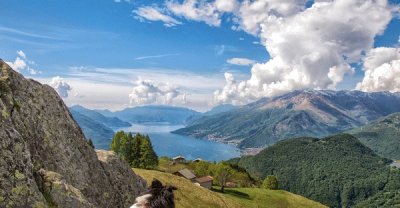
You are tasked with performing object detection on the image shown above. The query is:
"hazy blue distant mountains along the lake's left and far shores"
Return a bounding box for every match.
[69,105,202,150]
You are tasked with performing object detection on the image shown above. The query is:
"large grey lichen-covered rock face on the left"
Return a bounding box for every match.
[0,60,145,207]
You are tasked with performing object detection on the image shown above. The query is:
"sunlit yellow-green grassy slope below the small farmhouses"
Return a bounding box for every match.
[134,169,324,208]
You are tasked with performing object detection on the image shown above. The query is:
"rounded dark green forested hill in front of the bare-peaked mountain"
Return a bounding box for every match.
[232,134,400,207]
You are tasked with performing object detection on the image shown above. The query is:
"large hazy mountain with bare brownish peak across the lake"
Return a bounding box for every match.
[173,90,400,148]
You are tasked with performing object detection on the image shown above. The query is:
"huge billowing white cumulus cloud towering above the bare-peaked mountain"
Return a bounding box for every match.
[214,0,392,103]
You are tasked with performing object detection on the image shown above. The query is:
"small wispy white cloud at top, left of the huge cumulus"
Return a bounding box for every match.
[133,6,182,27]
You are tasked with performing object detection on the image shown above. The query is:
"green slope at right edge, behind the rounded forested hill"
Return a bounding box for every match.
[349,113,400,160]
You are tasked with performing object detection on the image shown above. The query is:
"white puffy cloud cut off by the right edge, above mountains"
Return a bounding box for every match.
[356,47,400,92]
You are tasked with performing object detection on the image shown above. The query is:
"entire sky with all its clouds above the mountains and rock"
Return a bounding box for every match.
[0,0,400,111]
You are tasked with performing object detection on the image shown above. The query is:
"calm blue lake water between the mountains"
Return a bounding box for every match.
[115,123,240,161]
